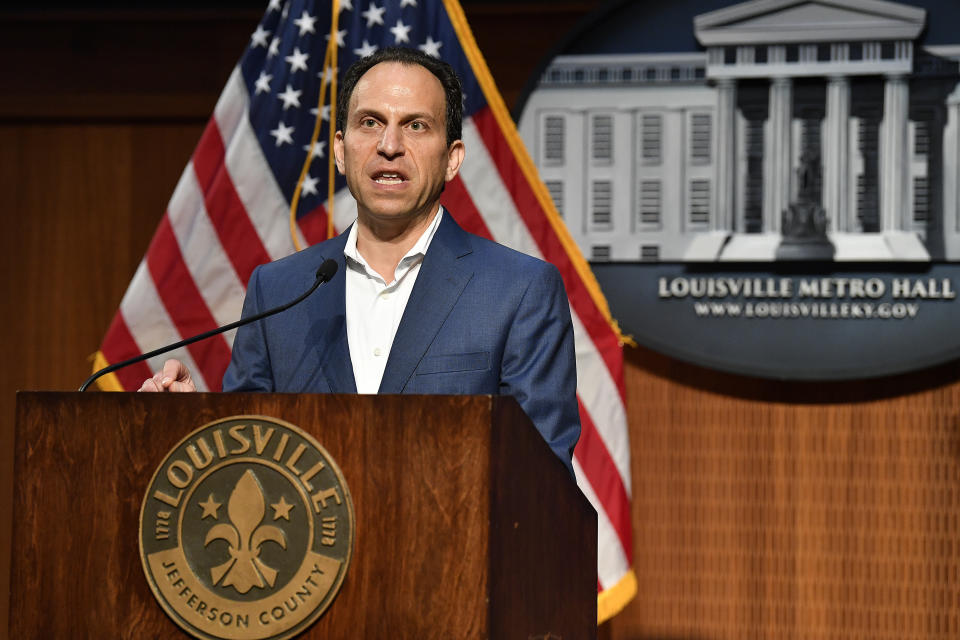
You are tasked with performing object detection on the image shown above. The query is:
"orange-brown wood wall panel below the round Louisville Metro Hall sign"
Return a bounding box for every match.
[611,350,960,640]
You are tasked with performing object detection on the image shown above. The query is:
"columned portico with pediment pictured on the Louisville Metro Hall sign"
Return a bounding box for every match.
[694,0,928,260]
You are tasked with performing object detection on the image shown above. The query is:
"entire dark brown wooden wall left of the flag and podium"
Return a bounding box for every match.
[0,12,249,638]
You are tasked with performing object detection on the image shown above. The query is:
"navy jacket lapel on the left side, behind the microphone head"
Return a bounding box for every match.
[305,232,357,393]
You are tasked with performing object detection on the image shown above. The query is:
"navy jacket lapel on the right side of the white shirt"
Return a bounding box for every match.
[379,212,473,393]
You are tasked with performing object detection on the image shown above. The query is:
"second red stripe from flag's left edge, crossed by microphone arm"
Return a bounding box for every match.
[147,215,230,391]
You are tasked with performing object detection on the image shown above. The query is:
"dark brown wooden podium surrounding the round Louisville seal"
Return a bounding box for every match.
[10,392,597,640]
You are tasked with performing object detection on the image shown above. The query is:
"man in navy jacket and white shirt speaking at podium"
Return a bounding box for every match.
[140,48,580,473]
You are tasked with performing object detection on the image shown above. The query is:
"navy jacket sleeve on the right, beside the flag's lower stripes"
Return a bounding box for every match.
[500,263,580,475]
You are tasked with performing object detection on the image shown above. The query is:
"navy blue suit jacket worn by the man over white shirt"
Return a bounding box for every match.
[223,212,580,472]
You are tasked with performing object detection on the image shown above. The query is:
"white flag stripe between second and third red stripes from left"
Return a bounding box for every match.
[167,161,244,336]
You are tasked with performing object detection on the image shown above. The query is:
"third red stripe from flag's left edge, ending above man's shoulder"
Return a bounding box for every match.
[193,118,270,286]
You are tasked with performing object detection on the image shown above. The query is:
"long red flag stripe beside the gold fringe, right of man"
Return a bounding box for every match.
[473,107,626,404]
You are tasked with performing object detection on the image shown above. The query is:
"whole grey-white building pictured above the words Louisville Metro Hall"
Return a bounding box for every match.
[520,0,960,262]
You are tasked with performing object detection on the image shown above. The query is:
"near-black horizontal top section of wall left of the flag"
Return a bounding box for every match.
[0,11,255,123]
